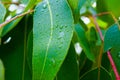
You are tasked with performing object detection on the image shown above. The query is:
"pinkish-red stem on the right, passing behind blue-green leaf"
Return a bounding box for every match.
[93,16,120,80]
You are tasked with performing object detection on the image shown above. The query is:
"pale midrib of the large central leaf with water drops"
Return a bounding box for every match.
[40,0,53,80]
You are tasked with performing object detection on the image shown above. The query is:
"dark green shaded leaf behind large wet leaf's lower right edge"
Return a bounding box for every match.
[56,44,79,80]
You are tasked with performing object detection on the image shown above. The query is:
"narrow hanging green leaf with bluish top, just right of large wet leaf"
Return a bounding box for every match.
[75,24,95,61]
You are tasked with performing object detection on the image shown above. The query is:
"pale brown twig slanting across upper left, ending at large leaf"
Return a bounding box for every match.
[0,10,34,29]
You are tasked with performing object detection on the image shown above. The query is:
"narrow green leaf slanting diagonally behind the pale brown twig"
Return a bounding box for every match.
[1,0,36,37]
